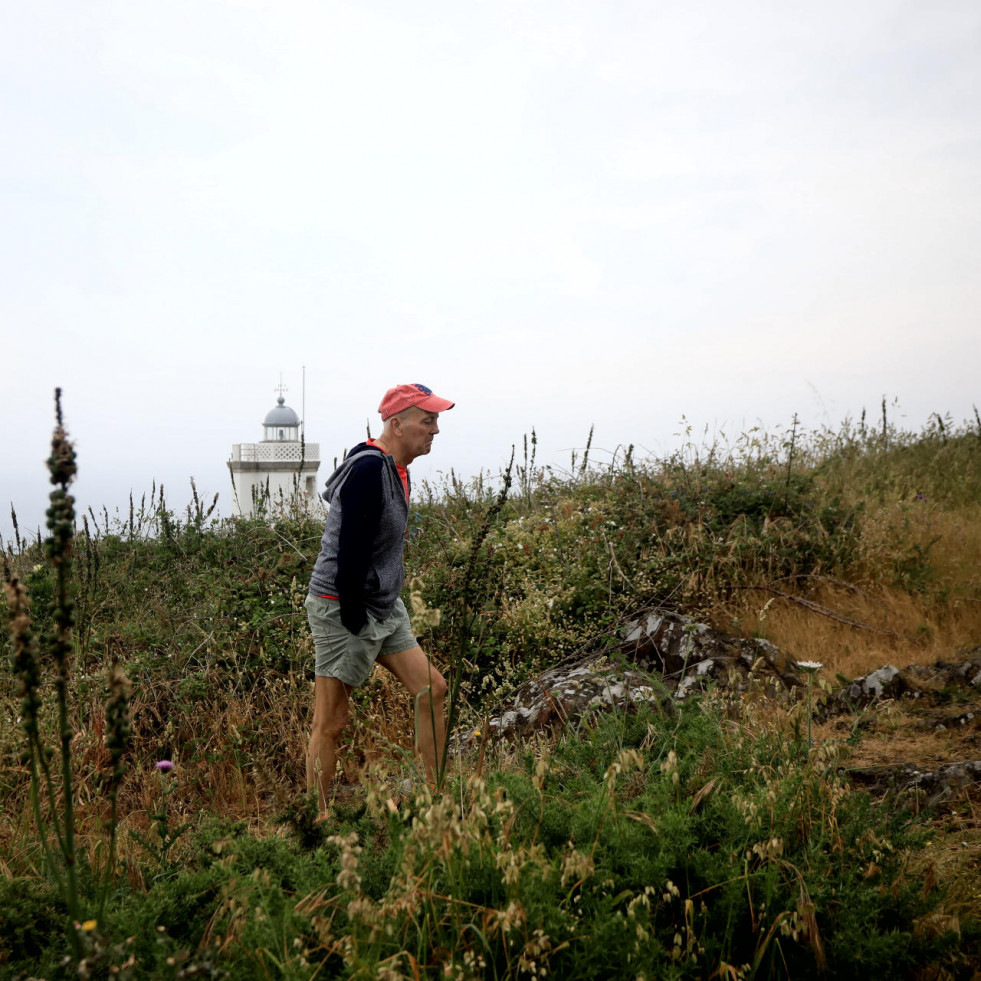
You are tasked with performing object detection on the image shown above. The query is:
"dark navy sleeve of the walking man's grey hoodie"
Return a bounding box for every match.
[337,453,384,634]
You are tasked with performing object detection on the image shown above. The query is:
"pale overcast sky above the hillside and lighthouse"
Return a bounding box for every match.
[0,0,981,540]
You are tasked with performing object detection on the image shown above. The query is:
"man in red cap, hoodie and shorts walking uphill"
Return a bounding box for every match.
[306,385,454,819]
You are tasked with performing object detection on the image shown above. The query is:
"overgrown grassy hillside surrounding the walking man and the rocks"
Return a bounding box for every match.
[0,394,981,978]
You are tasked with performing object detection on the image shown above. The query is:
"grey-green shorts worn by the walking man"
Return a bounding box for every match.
[304,594,416,688]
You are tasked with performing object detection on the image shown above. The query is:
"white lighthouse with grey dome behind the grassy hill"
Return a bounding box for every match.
[228,385,320,517]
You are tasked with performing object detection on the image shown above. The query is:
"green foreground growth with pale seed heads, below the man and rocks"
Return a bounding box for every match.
[0,705,954,978]
